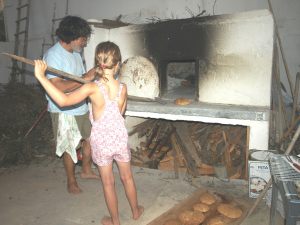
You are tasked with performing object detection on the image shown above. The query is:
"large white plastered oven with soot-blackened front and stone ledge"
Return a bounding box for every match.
[85,10,274,153]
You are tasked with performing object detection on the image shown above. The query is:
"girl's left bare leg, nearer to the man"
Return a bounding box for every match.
[98,163,120,225]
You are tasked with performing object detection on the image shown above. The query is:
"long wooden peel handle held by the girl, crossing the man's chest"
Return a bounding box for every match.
[0,52,89,84]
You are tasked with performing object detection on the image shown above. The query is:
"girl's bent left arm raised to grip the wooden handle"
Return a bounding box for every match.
[34,60,93,107]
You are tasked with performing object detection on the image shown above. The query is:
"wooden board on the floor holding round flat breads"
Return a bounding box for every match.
[147,188,251,225]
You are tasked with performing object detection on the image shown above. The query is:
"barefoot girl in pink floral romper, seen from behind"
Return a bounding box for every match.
[35,41,144,225]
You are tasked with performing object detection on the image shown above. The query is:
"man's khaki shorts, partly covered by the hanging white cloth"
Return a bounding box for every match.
[50,112,92,142]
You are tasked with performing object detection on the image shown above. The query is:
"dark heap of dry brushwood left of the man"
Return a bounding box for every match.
[0,83,53,167]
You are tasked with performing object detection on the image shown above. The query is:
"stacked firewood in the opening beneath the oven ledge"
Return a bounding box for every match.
[129,119,248,179]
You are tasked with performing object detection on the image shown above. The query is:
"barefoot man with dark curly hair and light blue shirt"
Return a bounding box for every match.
[44,16,99,194]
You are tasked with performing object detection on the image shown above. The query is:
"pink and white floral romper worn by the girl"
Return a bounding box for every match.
[90,81,131,166]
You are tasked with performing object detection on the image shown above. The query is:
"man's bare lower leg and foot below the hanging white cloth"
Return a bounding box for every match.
[63,152,81,194]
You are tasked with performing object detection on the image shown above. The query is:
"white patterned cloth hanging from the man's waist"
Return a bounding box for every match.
[56,113,81,163]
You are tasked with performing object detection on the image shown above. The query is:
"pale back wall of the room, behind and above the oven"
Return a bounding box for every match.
[0,0,300,99]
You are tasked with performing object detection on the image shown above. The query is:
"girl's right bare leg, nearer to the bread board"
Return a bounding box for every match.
[117,162,144,220]
